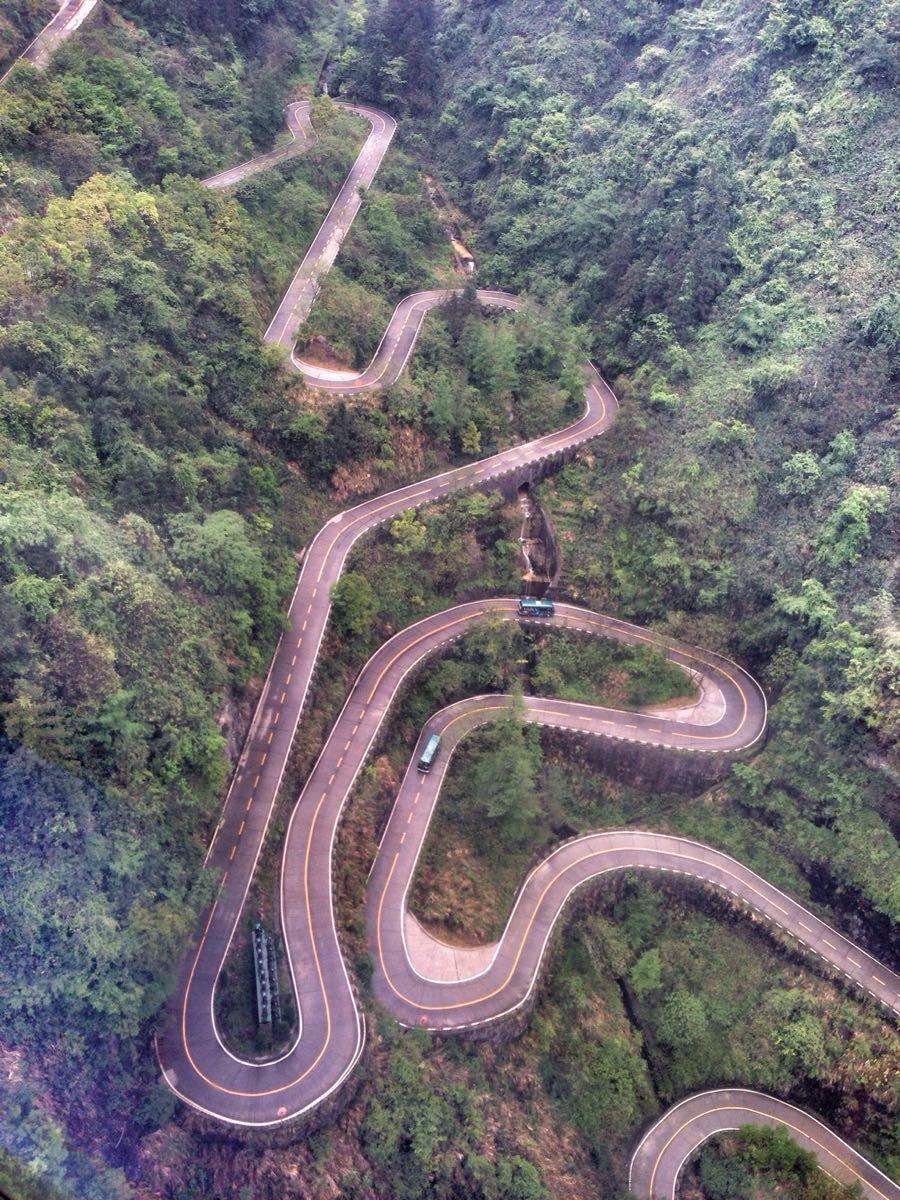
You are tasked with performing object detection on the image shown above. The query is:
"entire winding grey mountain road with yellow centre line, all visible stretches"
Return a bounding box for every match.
[8,35,900,1200]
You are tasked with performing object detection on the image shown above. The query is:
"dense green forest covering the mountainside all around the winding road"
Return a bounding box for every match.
[0,0,900,1200]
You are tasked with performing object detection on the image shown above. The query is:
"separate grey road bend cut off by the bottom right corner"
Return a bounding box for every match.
[629,1087,900,1200]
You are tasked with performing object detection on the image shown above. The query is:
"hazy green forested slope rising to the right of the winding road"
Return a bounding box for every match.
[369,0,900,922]
